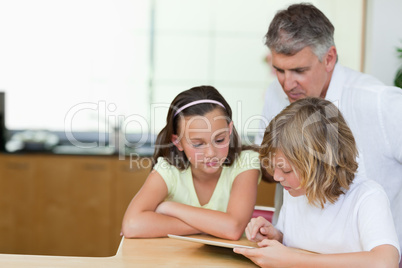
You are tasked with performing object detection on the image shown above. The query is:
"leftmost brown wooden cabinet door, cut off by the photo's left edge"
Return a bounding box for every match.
[0,155,35,254]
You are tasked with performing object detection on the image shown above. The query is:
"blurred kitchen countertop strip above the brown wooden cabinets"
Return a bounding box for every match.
[4,130,155,157]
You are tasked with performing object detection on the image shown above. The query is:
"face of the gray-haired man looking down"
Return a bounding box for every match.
[271,47,336,102]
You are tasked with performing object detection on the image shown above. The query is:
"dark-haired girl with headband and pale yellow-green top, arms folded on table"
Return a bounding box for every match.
[122,86,261,240]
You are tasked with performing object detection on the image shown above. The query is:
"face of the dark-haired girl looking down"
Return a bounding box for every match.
[172,108,233,174]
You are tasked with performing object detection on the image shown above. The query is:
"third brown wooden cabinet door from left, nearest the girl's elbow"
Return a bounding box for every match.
[72,157,116,256]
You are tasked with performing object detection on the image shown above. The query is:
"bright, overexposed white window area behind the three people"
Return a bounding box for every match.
[0,0,374,149]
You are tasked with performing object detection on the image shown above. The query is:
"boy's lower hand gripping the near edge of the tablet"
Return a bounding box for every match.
[233,239,295,267]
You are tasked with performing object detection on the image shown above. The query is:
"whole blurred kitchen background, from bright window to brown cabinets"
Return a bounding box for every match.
[0,0,402,256]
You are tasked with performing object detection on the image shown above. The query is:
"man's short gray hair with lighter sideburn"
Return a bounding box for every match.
[265,3,335,61]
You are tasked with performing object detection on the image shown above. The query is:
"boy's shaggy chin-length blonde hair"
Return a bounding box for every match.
[260,98,358,208]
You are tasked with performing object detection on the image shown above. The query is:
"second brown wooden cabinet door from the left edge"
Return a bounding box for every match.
[32,156,76,255]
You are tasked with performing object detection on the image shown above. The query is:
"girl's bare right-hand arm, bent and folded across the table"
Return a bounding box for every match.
[158,169,260,240]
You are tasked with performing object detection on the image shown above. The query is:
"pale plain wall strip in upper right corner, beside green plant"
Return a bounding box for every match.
[364,0,402,85]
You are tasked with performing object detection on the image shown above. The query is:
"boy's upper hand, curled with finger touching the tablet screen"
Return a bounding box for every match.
[245,216,282,242]
